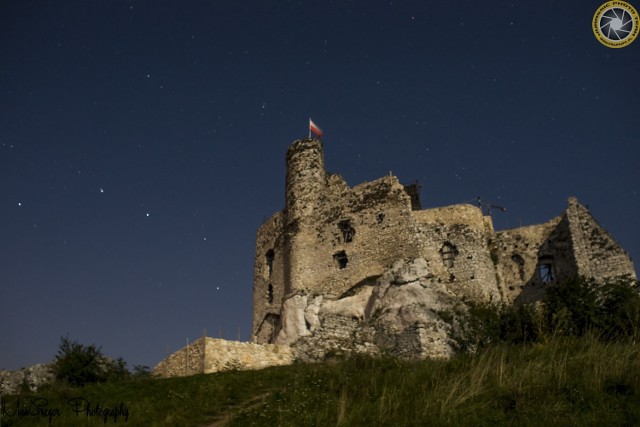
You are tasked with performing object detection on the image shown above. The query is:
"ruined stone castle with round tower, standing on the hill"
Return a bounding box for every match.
[253,139,635,356]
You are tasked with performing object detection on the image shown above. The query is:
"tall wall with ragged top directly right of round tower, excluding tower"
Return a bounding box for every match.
[292,175,418,298]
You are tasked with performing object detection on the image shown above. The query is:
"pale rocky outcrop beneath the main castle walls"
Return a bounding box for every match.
[276,258,466,361]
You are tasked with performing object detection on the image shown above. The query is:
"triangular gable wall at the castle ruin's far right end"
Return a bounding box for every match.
[566,197,636,279]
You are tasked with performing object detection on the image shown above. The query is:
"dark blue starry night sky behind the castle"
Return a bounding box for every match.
[0,0,640,369]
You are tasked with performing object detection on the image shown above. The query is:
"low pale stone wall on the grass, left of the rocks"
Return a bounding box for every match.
[153,337,294,378]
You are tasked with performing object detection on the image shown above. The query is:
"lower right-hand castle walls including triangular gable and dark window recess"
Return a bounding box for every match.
[490,198,635,302]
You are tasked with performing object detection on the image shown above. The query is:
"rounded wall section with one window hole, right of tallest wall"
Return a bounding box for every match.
[412,204,502,302]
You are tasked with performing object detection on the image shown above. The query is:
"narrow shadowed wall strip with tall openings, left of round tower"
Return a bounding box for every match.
[252,212,285,342]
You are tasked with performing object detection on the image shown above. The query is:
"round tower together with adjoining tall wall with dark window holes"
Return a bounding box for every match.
[284,140,418,297]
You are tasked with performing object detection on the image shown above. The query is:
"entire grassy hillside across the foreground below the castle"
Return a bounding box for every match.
[2,337,640,427]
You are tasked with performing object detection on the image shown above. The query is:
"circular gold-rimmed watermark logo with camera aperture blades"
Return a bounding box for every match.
[592,1,640,48]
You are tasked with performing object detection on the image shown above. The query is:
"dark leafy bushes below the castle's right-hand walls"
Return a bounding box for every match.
[454,277,640,352]
